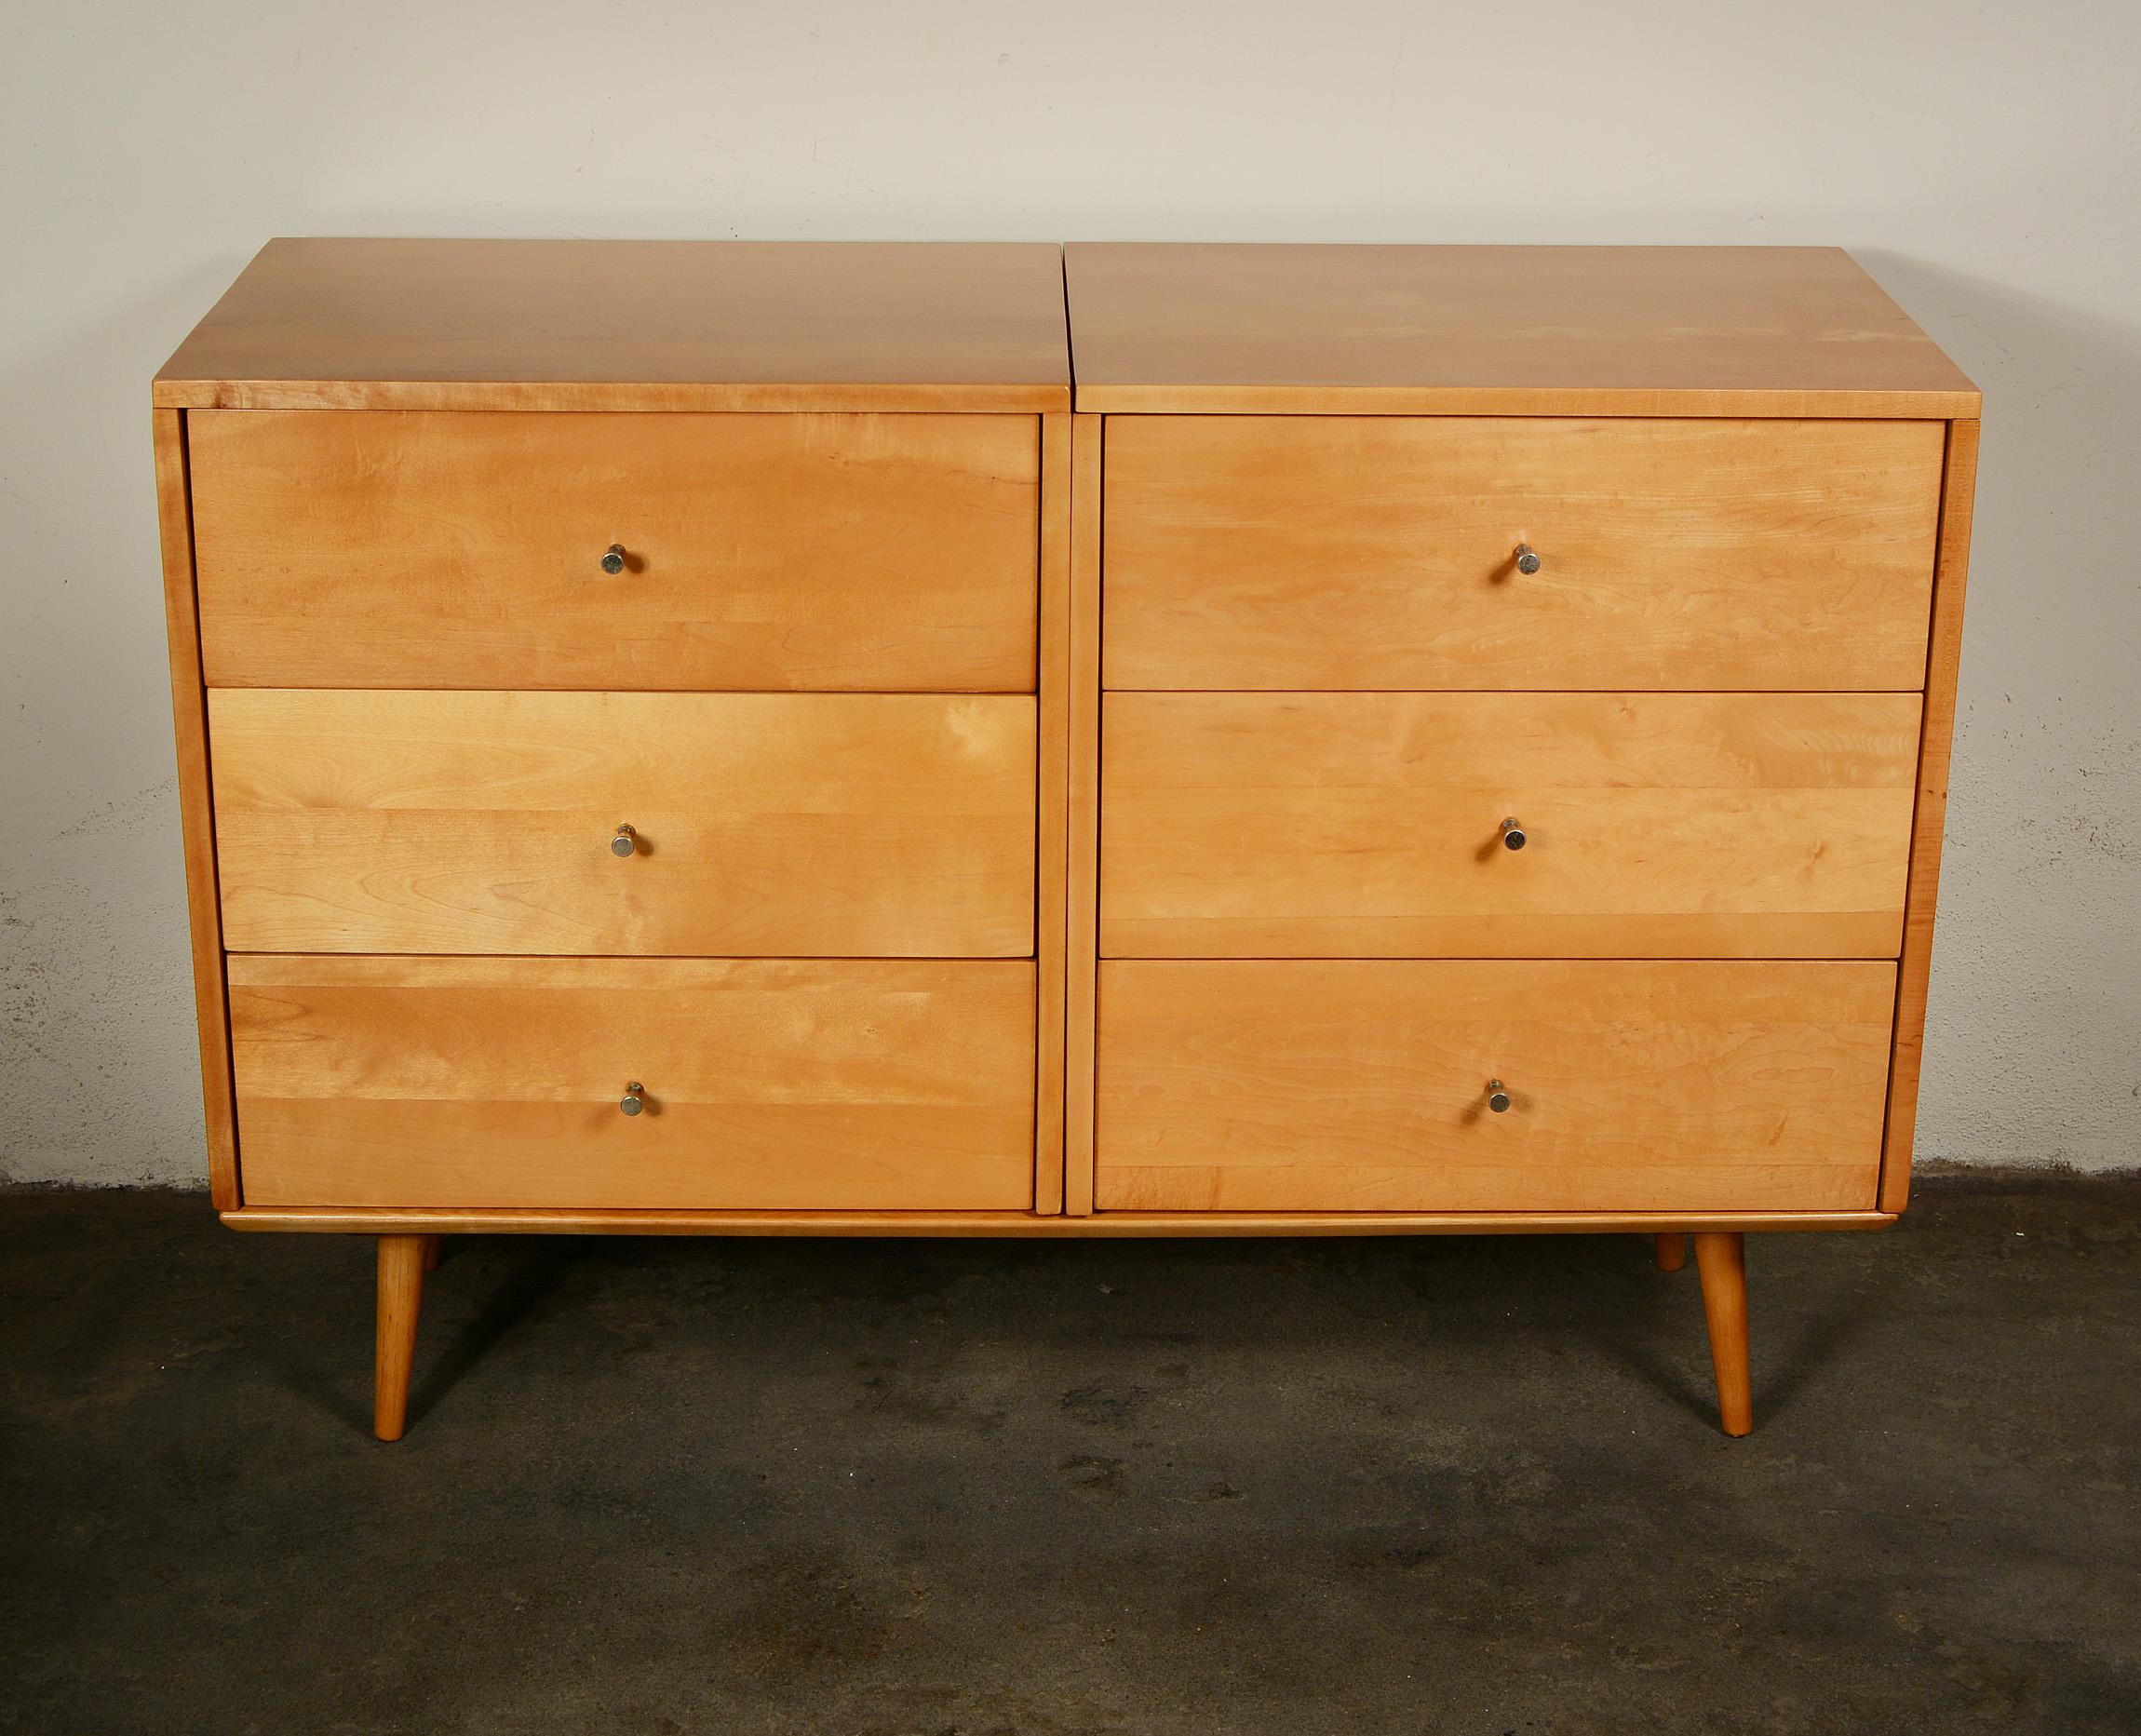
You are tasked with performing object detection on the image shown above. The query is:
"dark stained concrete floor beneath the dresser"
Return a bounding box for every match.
[0,1178,2141,1736]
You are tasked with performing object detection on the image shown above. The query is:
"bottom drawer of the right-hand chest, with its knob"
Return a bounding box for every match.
[1094,959,1895,1212]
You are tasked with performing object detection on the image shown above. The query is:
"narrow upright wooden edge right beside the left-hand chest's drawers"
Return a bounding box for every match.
[1034,415,1070,1214]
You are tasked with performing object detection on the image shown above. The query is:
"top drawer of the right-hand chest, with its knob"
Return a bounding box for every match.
[1103,415,1944,692]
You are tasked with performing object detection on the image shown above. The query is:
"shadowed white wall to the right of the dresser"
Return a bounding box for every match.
[1858,252,2141,1169]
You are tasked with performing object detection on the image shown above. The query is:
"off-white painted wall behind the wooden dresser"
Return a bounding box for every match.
[0,0,2141,1181]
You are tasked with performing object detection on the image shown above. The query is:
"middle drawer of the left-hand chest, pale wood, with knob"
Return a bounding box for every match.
[208,687,1036,957]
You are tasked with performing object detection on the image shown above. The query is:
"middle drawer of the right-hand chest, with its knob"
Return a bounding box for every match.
[1100,693,1920,959]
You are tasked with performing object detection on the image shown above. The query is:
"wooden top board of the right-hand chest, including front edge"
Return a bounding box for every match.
[1064,242,1978,417]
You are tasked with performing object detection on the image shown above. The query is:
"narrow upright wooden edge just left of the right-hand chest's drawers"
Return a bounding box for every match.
[1064,415,1105,1216]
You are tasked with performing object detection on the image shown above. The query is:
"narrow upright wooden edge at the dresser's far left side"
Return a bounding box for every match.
[155,409,242,1212]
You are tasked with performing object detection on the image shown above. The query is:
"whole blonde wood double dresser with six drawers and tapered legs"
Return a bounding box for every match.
[155,242,1978,1438]
